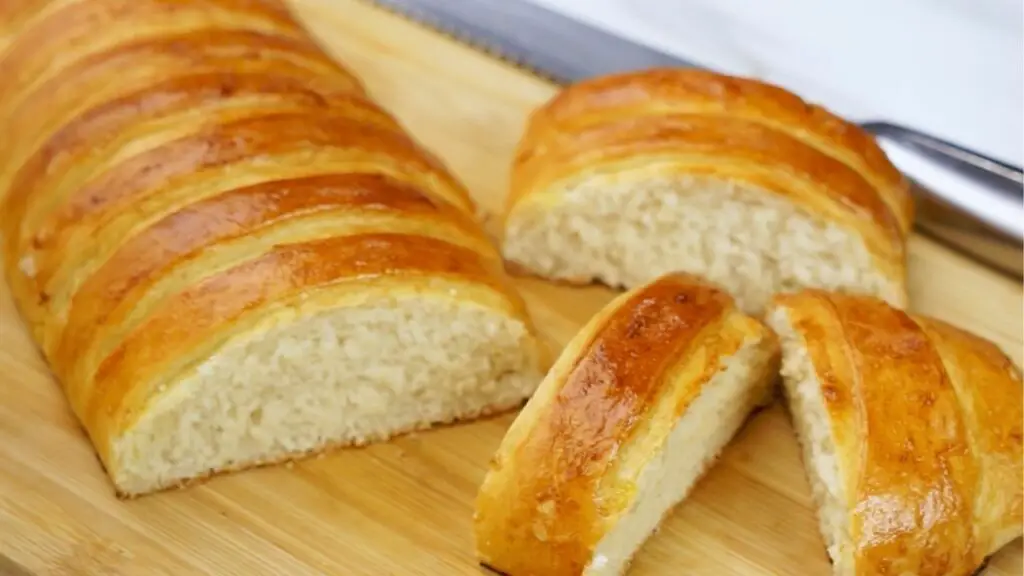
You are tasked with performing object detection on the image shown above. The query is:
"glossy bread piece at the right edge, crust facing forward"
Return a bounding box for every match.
[768,290,1024,576]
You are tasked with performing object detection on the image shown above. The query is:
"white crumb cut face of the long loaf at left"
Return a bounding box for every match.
[108,297,543,497]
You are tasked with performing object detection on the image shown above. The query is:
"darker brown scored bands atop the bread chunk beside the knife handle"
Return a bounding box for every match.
[512,69,913,235]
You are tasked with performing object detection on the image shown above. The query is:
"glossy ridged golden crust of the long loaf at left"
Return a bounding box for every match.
[0,0,532,479]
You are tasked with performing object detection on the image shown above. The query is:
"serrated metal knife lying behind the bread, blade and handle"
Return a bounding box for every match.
[371,0,1024,278]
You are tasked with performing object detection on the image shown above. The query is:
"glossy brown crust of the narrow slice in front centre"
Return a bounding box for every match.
[475,274,773,576]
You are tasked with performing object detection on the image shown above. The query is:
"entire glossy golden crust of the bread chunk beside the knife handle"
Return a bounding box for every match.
[505,69,913,281]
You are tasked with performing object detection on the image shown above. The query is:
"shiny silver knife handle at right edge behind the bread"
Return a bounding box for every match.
[862,122,1024,278]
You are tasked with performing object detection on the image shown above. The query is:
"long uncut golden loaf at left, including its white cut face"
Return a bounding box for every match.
[0,0,543,495]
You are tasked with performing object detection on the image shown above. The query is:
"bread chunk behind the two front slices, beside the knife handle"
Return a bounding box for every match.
[503,69,912,314]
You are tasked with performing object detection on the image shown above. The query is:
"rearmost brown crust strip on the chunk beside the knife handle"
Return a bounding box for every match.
[513,69,913,235]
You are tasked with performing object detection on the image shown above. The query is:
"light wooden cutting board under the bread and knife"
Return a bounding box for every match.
[0,0,1024,576]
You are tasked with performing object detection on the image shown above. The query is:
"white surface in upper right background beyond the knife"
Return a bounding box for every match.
[524,0,1024,165]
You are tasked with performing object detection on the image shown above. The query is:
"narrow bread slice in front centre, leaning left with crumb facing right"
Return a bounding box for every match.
[474,275,778,576]
